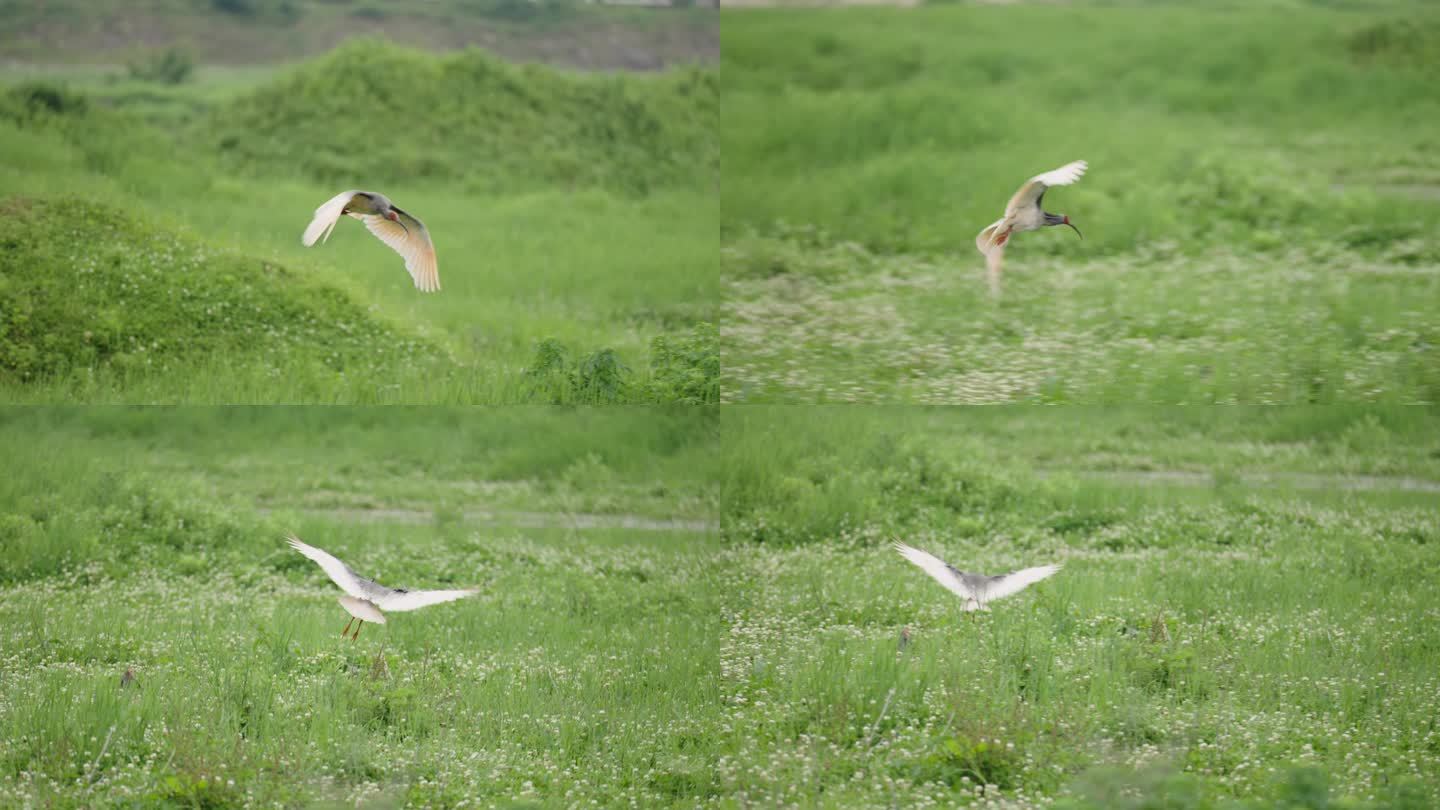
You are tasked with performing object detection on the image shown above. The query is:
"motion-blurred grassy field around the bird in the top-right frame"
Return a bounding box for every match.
[721,3,1440,404]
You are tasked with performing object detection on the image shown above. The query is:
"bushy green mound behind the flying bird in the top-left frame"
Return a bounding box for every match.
[207,40,720,193]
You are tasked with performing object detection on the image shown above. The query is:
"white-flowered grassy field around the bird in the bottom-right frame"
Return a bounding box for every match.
[717,406,1440,810]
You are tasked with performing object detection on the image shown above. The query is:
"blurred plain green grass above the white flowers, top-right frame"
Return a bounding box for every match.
[721,4,1440,257]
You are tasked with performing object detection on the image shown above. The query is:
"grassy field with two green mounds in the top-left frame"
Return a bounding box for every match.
[0,40,719,404]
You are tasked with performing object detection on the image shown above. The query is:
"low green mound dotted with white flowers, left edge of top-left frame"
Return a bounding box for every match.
[0,197,444,382]
